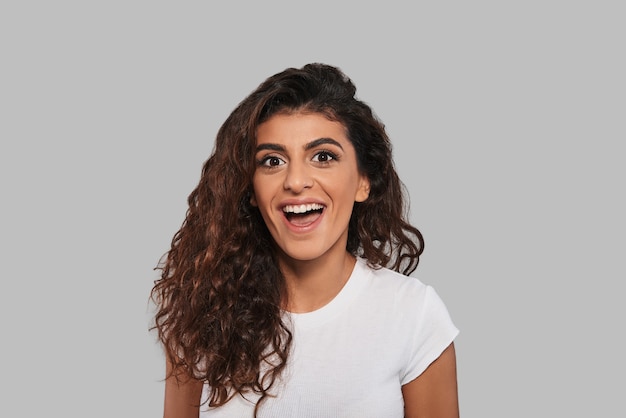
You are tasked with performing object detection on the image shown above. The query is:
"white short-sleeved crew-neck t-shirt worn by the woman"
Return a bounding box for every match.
[200,259,459,418]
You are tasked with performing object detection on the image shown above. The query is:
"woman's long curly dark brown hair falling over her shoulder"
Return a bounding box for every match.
[151,63,424,410]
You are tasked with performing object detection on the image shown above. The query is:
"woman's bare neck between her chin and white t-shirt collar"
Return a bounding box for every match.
[280,252,356,313]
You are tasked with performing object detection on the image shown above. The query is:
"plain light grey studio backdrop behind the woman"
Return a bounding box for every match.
[0,0,626,418]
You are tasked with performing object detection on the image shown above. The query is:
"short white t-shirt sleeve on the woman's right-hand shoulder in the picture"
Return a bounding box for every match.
[400,286,459,385]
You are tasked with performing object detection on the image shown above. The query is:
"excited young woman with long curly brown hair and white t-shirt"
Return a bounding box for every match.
[152,64,459,418]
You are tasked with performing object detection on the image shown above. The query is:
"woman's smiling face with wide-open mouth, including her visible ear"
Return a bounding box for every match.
[250,113,369,261]
